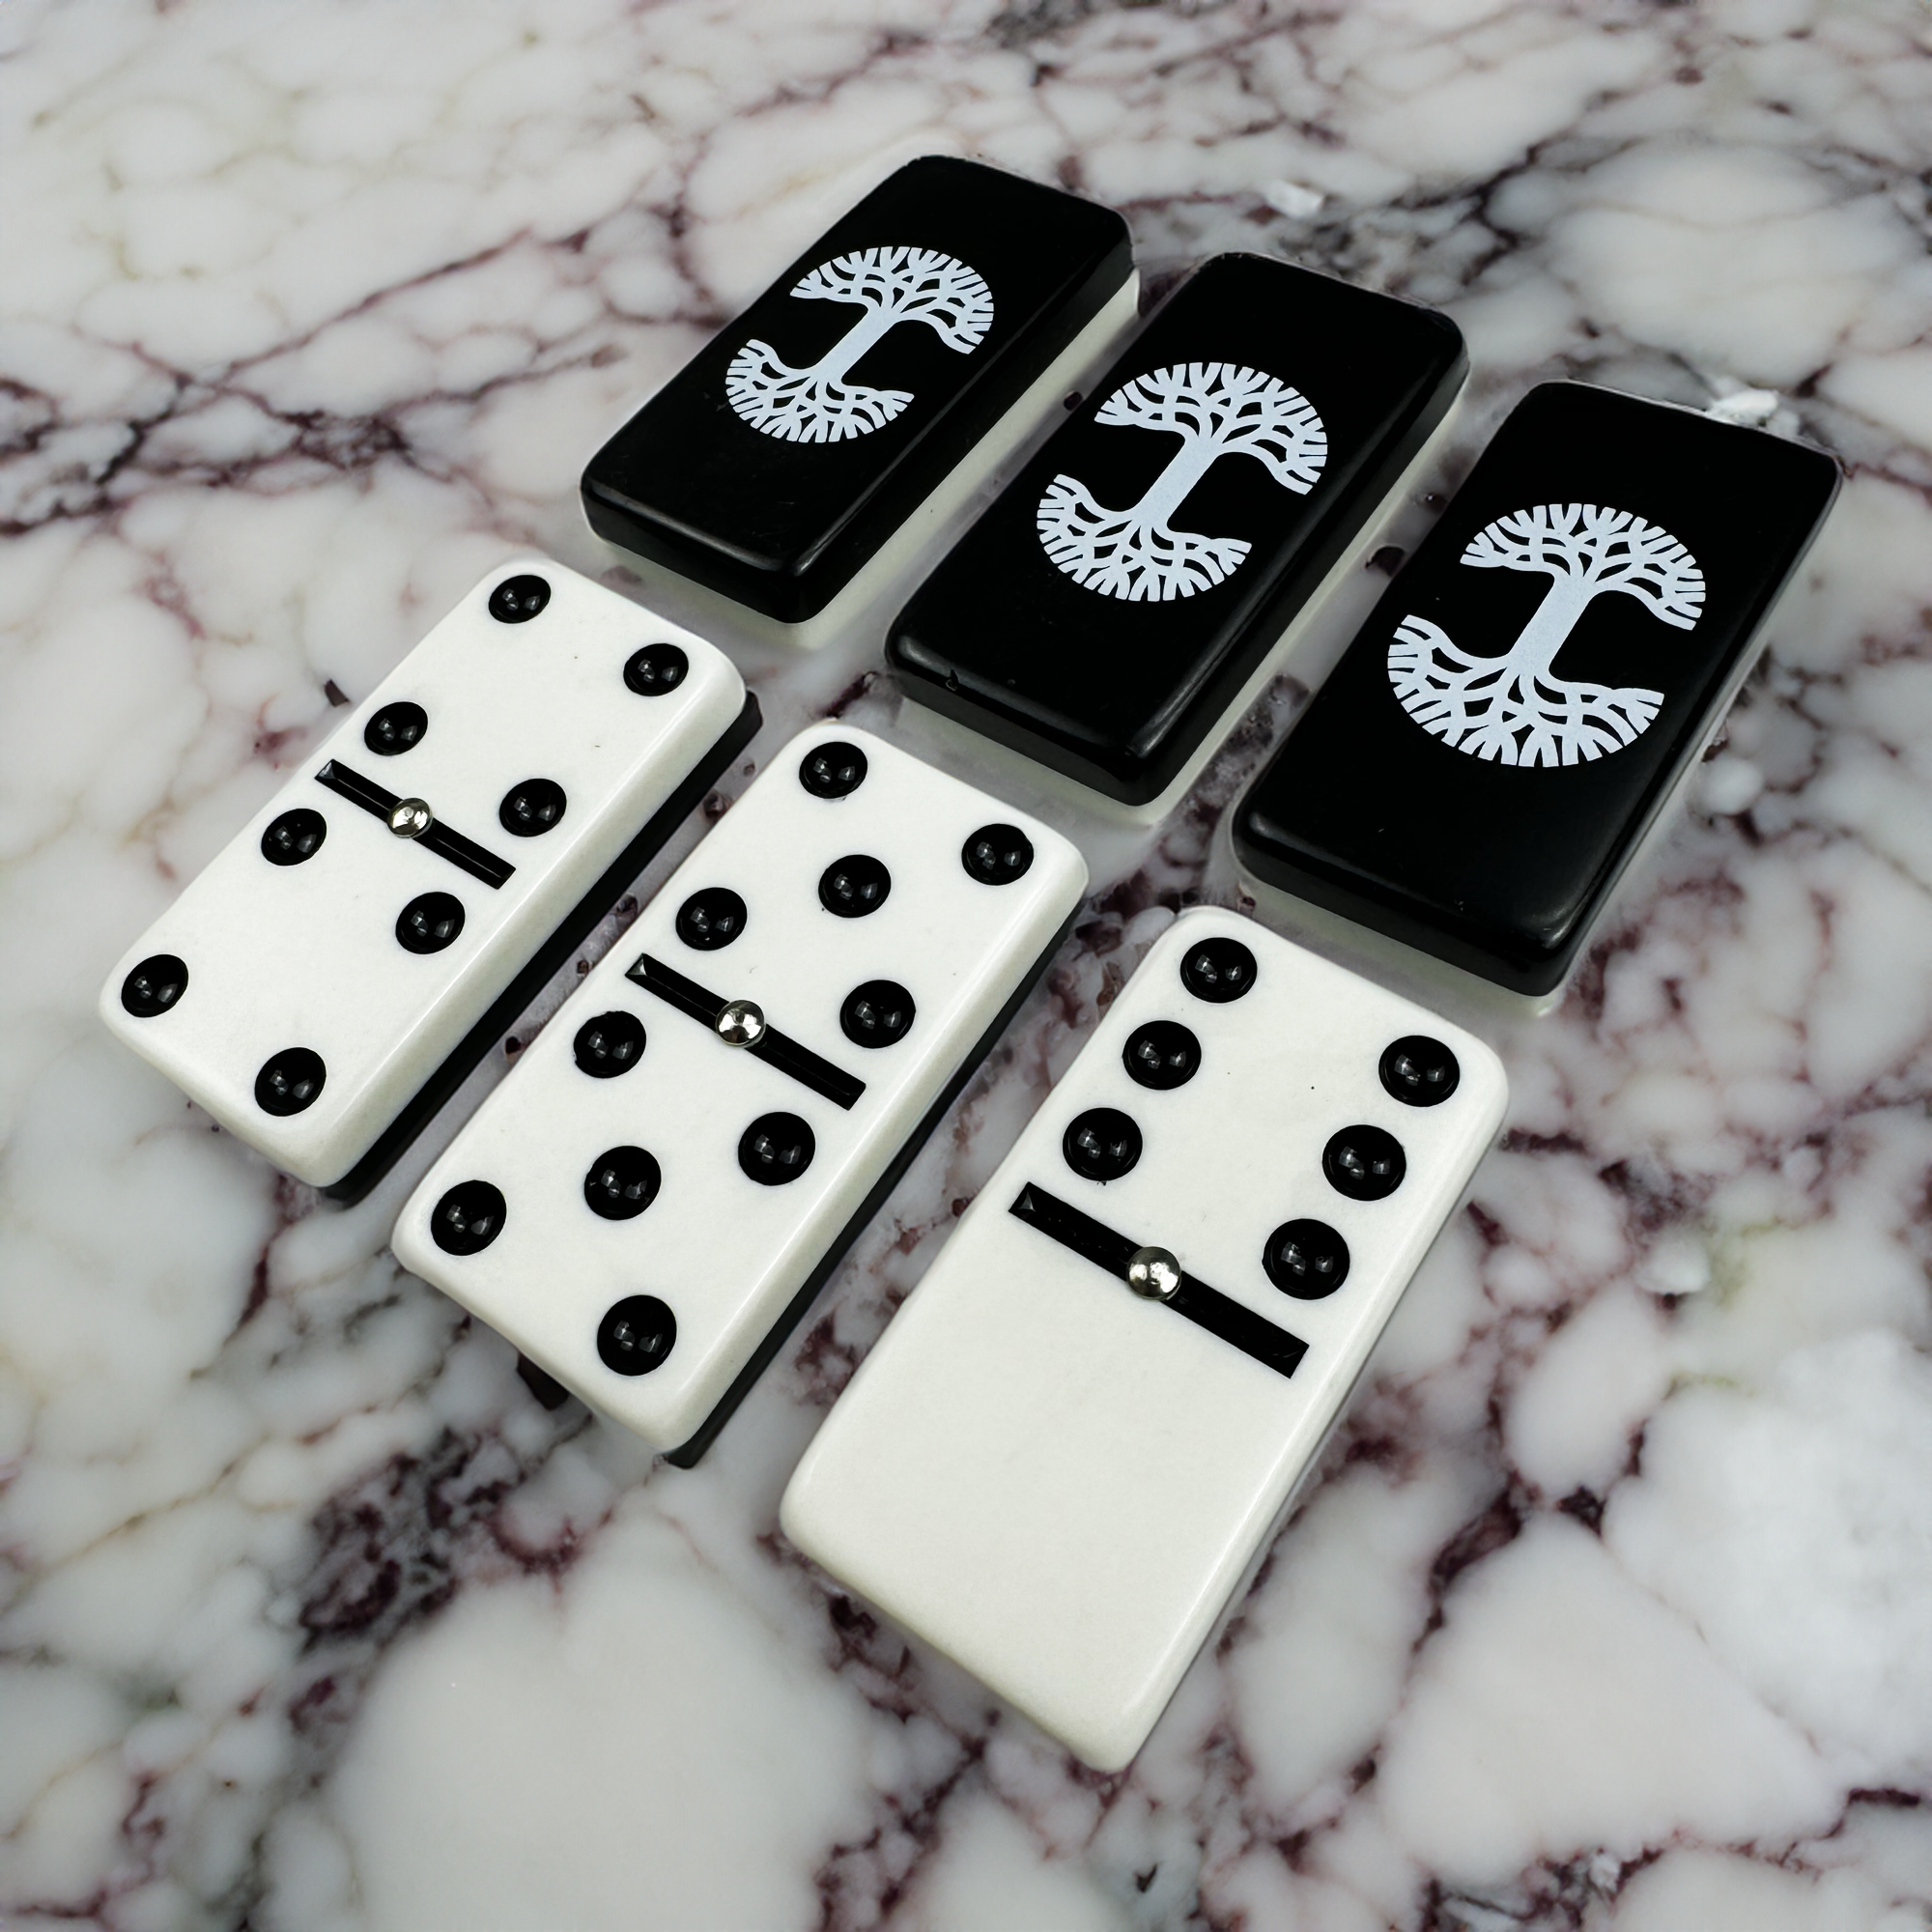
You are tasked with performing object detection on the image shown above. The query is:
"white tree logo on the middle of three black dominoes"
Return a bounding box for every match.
[1034,363,1327,603]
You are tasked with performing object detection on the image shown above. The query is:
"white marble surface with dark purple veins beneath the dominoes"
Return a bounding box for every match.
[11,0,1932,1932]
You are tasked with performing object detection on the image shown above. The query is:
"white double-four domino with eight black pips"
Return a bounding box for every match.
[100,556,757,1202]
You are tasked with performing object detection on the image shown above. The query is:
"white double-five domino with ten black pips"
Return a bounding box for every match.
[394,724,1086,1466]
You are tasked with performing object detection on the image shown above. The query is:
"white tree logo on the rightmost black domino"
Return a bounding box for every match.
[1389,502,1704,765]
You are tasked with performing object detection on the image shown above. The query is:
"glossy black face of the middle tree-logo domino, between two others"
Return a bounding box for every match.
[887,255,1466,804]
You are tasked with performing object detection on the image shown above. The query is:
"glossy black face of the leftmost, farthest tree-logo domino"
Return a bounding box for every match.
[583,156,1132,622]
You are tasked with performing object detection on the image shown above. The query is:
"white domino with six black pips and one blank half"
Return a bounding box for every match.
[781,910,1505,1772]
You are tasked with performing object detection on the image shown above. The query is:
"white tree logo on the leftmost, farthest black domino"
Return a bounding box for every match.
[724,247,993,442]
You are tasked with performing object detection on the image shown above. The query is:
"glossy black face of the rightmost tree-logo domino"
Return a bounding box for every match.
[1235,383,1837,993]
